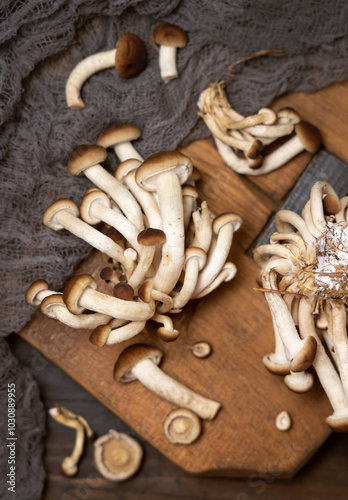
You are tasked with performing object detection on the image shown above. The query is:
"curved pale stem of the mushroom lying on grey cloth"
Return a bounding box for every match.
[65,49,116,108]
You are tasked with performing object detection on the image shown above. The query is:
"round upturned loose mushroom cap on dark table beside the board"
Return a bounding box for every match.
[94,429,143,481]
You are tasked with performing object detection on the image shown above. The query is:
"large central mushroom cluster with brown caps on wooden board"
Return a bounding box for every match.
[26,124,241,347]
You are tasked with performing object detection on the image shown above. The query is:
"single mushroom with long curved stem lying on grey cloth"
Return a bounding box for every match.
[65,33,147,109]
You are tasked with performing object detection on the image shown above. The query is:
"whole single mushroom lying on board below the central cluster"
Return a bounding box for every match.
[114,344,221,420]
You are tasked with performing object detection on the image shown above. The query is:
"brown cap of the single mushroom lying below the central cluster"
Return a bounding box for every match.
[114,344,163,383]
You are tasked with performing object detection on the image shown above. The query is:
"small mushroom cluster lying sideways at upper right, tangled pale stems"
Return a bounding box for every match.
[197,83,321,175]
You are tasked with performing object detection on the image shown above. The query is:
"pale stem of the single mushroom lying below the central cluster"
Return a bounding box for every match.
[132,359,221,420]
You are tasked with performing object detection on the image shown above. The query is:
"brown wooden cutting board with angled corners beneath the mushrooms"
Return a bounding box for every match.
[19,84,348,477]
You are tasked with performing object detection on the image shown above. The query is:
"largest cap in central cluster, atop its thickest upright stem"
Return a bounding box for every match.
[135,151,193,192]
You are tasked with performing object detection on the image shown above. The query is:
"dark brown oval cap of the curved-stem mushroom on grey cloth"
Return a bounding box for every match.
[115,33,147,78]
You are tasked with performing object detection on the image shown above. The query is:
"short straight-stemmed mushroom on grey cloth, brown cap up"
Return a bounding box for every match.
[152,23,187,83]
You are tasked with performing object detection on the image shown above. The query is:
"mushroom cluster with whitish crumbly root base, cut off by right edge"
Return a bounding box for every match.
[254,181,348,432]
